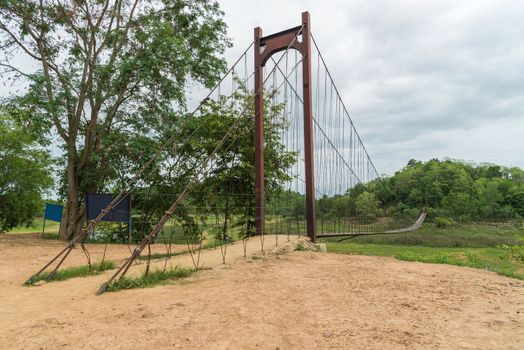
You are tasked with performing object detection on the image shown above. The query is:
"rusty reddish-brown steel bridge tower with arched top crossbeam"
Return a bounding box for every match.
[254,12,316,242]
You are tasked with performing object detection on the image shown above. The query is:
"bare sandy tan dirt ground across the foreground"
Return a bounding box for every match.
[0,235,524,349]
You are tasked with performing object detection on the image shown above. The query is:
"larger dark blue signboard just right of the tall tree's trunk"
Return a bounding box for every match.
[86,193,131,223]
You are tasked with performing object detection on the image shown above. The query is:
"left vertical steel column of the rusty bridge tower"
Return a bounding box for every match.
[254,27,265,239]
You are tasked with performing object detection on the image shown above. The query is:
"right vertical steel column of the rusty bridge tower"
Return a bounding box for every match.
[302,12,317,242]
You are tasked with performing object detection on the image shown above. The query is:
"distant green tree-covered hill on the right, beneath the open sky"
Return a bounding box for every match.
[348,159,524,222]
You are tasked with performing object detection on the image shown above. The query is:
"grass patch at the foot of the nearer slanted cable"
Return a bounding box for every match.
[106,266,195,292]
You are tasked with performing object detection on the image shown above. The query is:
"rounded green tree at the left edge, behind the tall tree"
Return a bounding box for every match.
[0,117,52,232]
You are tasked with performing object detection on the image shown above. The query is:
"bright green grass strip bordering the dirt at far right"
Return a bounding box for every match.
[327,242,524,279]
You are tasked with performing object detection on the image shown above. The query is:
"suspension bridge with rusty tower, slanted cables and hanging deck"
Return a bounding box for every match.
[27,12,425,294]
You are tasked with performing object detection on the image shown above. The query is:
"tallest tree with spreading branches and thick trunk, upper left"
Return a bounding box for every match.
[0,0,229,238]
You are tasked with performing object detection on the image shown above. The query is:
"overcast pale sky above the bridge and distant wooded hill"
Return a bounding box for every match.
[220,0,524,174]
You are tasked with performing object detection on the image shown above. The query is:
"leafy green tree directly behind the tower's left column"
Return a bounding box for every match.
[191,89,296,241]
